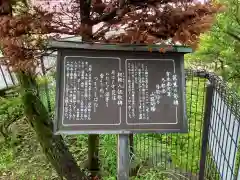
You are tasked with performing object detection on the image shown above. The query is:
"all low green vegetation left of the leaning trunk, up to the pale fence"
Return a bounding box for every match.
[0,92,56,180]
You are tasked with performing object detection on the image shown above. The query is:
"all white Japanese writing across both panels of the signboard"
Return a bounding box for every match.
[63,59,179,125]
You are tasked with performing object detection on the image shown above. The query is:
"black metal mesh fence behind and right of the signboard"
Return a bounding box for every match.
[1,62,240,180]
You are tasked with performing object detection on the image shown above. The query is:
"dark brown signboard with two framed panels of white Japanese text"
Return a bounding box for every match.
[52,42,191,134]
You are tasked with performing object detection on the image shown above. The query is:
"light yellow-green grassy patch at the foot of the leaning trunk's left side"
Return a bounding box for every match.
[0,119,59,180]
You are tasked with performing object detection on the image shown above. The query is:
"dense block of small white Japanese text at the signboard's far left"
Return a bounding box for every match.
[64,61,96,120]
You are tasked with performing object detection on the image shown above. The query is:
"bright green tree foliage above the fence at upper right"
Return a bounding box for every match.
[188,0,240,84]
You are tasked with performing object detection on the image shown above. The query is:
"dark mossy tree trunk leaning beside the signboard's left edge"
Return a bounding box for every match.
[19,73,88,180]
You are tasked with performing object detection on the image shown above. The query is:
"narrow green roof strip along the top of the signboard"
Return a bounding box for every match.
[48,40,193,53]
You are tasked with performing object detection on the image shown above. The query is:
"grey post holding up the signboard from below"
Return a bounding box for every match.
[118,134,130,180]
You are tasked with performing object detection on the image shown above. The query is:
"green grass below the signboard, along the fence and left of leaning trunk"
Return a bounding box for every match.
[0,75,216,180]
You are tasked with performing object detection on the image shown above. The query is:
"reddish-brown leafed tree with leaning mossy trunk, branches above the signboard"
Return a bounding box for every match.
[0,0,226,179]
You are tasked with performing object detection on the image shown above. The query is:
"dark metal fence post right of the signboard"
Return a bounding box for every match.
[199,83,214,180]
